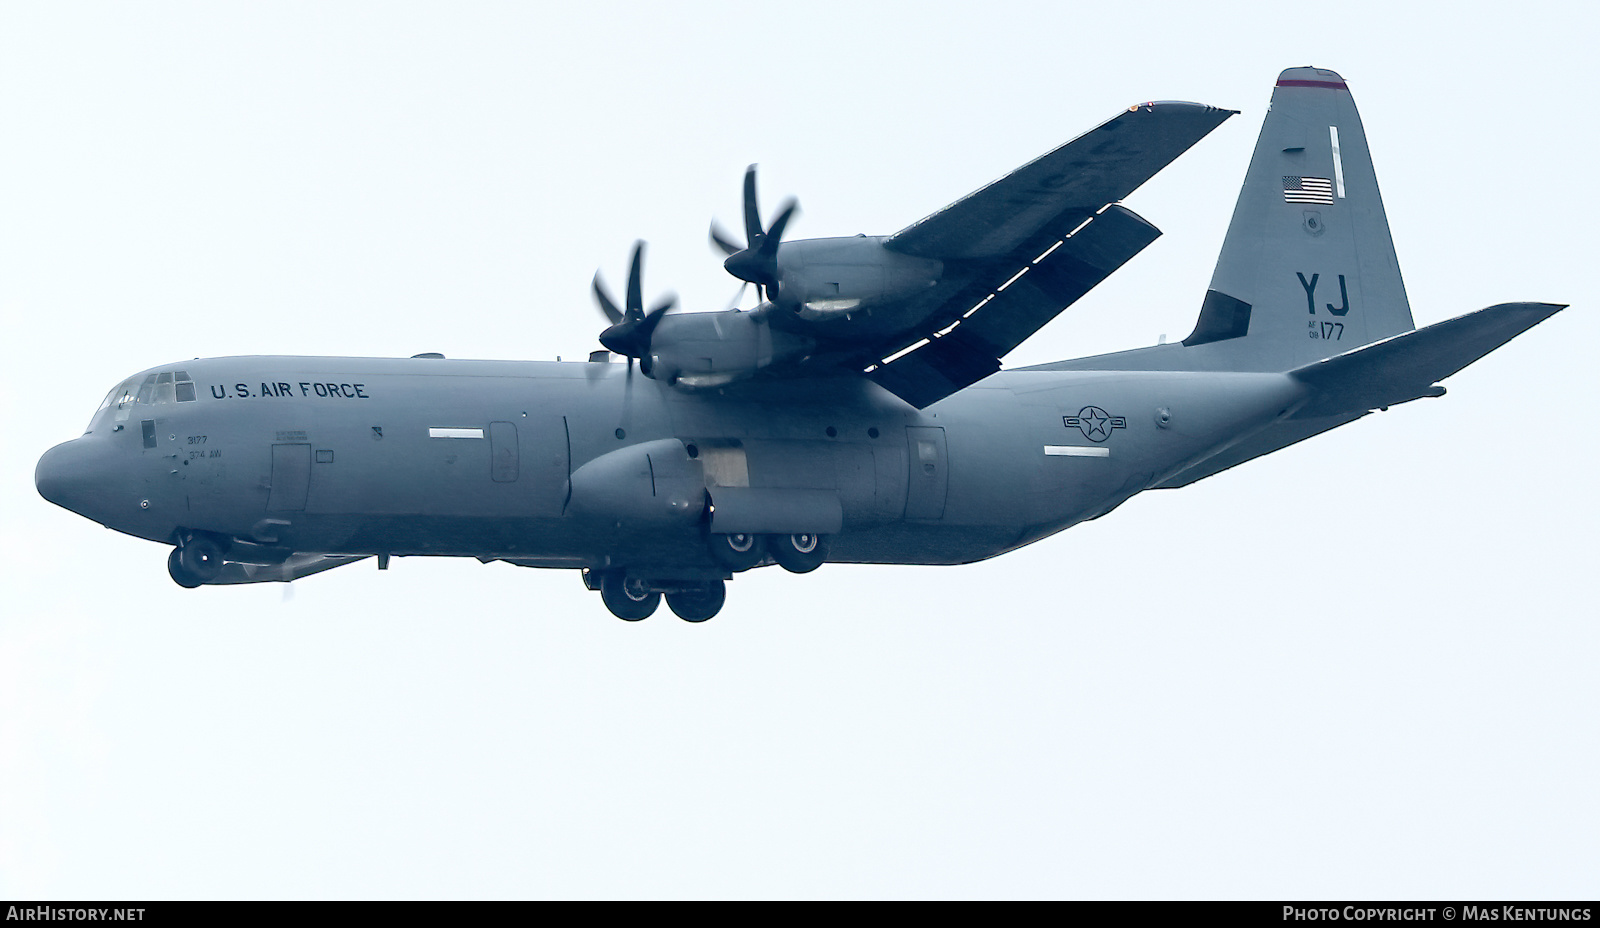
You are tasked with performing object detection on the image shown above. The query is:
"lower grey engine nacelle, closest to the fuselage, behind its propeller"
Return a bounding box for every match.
[645,309,813,387]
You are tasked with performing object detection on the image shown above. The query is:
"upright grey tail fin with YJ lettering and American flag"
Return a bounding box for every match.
[1184,67,1414,371]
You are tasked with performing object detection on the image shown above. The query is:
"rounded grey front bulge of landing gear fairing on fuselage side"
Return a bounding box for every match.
[568,438,706,525]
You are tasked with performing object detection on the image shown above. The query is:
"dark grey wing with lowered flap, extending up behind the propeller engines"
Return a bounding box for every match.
[850,102,1235,406]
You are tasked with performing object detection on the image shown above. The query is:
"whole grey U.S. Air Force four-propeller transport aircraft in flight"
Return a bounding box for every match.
[35,67,1563,622]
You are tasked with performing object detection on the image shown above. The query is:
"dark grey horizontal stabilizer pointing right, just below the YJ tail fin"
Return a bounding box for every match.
[1290,302,1566,419]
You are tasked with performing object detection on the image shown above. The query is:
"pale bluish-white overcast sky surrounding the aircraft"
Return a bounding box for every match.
[0,0,1600,899]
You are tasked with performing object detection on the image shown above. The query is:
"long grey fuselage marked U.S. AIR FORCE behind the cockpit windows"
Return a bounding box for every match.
[37,357,1304,574]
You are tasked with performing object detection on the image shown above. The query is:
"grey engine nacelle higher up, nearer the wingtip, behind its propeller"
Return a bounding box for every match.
[778,235,944,318]
